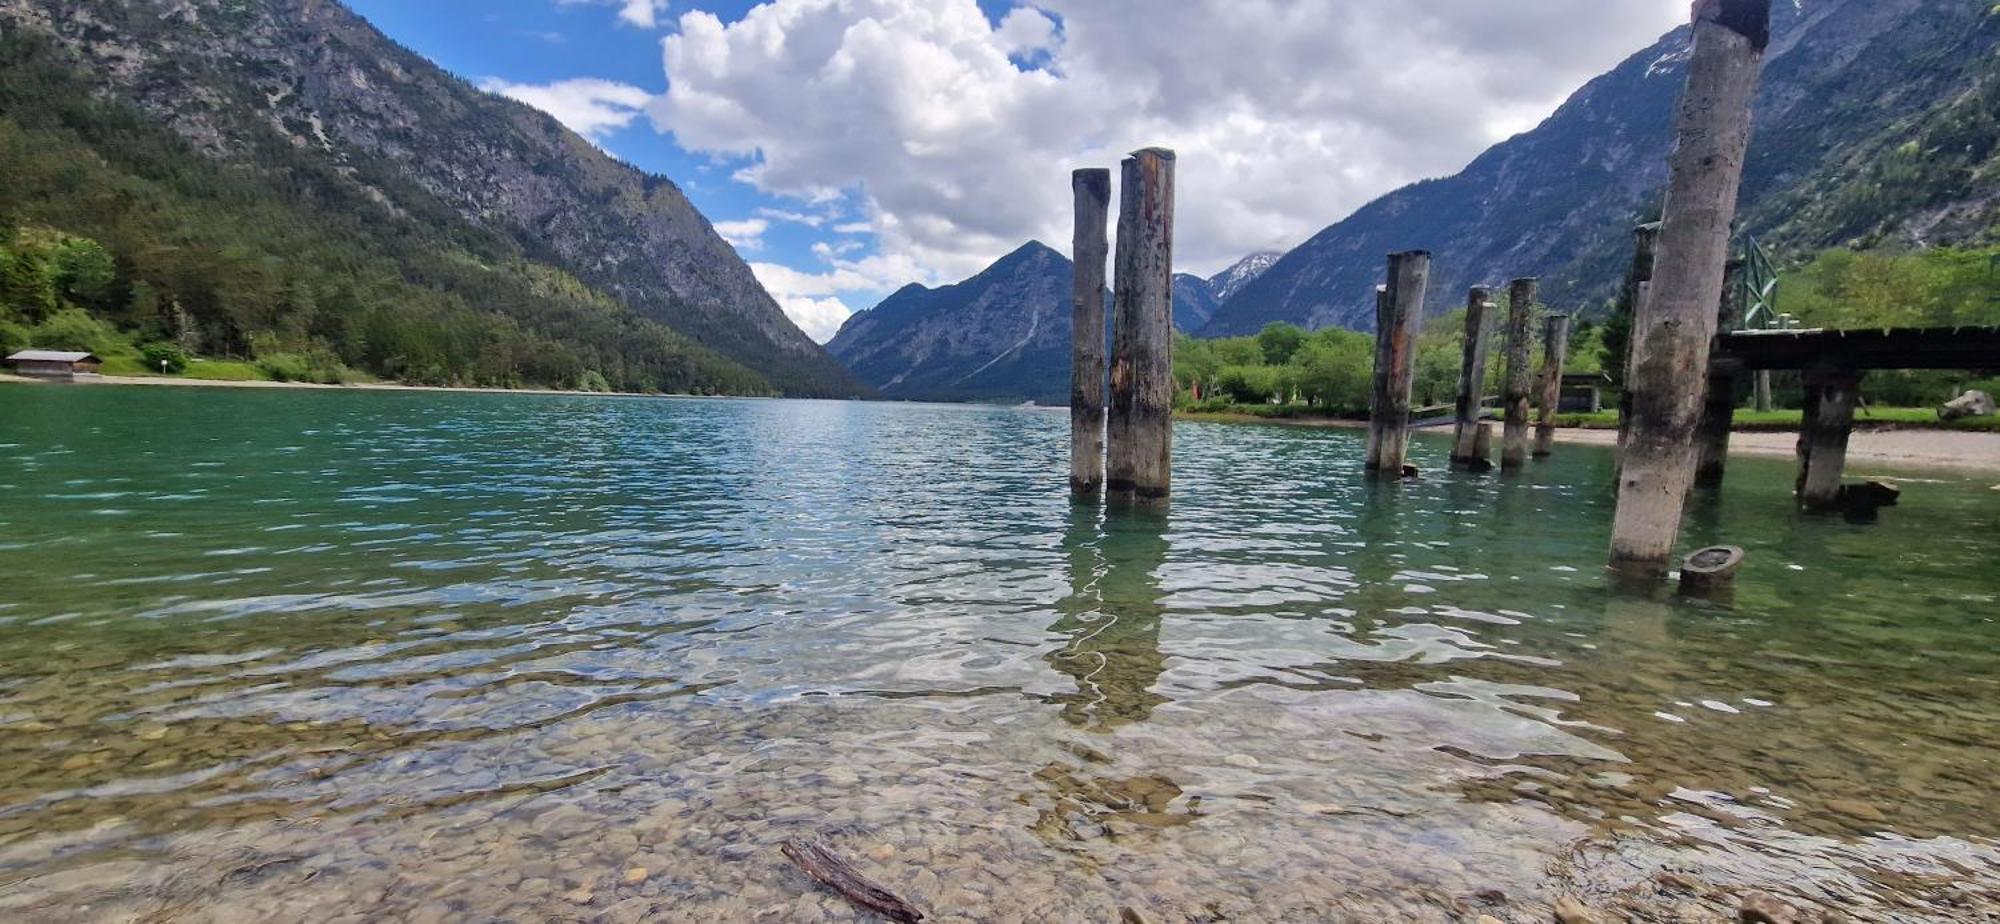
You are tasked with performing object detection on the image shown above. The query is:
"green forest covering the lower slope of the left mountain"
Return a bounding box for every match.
[0,36,774,394]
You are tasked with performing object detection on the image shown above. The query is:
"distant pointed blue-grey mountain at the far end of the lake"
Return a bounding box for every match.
[826,240,1214,404]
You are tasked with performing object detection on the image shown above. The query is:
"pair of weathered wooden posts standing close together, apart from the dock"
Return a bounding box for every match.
[1070,148,1174,506]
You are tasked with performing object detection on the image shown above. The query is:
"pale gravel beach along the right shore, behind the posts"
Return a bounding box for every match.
[1176,414,2000,474]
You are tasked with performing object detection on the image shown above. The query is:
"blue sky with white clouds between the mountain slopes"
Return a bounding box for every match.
[348,0,1690,342]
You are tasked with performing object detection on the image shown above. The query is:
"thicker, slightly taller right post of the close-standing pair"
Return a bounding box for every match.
[1106,148,1174,504]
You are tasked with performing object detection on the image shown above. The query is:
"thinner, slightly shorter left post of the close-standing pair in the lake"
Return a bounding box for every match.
[1070,168,1112,498]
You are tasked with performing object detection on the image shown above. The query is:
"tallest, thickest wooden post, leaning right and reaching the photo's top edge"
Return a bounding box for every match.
[1612,0,1770,576]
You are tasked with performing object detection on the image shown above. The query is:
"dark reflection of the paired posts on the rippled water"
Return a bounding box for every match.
[1044,508,1166,732]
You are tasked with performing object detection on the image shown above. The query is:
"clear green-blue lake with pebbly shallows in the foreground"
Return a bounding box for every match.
[0,386,2000,922]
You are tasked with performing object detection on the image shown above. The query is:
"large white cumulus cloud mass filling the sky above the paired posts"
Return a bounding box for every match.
[648,0,1688,290]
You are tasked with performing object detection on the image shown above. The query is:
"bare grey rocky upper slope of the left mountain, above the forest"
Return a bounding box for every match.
[0,0,862,396]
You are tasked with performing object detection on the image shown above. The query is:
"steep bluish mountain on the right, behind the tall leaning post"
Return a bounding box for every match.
[1202,0,2000,336]
